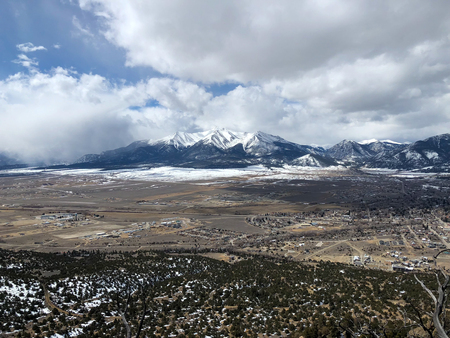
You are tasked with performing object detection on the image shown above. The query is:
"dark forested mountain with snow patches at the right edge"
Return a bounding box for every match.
[368,134,450,171]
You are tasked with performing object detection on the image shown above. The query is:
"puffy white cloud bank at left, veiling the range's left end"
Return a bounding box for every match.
[0,67,218,163]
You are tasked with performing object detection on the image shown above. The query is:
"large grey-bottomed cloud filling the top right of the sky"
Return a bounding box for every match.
[79,0,450,83]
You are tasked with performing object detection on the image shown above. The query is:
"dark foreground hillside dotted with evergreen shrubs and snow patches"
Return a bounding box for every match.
[0,250,442,338]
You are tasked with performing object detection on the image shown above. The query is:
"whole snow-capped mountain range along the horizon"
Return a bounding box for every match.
[0,129,450,172]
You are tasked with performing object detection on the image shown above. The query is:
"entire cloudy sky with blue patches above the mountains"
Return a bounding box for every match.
[0,0,450,163]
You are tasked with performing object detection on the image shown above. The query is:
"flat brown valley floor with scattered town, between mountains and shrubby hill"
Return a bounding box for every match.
[0,172,450,271]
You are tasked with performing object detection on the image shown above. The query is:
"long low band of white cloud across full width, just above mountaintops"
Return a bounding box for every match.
[0,68,450,161]
